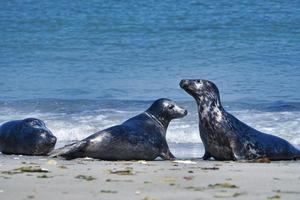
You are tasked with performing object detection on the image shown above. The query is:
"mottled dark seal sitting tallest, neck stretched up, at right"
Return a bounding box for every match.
[180,80,300,160]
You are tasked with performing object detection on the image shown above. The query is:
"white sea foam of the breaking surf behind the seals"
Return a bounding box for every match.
[0,109,300,145]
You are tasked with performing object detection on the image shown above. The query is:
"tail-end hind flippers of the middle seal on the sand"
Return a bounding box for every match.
[49,140,88,159]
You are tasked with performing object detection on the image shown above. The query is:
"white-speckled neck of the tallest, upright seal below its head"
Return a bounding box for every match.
[197,101,224,123]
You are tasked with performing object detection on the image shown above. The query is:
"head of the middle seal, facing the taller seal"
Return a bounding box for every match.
[147,98,187,122]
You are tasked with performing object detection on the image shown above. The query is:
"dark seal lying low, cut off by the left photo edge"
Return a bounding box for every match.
[0,118,56,155]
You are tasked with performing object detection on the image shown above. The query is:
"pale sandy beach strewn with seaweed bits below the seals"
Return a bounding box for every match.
[0,155,300,200]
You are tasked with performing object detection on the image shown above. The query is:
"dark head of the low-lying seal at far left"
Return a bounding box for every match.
[21,118,56,155]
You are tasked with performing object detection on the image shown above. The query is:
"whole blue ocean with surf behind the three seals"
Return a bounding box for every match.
[0,0,300,157]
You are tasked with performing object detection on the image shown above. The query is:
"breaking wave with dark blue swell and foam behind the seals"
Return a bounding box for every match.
[0,101,300,145]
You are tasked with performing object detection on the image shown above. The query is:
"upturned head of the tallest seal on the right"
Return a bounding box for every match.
[179,79,220,105]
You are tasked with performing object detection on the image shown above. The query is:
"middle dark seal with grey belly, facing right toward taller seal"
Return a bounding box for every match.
[50,99,187,160]
